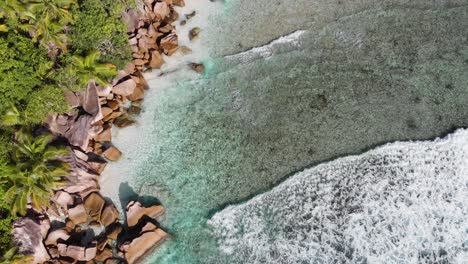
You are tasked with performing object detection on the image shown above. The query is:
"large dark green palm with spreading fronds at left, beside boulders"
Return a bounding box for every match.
[0,130,68,215]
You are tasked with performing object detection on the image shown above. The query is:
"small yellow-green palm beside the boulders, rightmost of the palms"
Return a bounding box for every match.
[72,51,117,85]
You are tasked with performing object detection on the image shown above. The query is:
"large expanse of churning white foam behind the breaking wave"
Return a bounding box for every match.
[209,130,468,263]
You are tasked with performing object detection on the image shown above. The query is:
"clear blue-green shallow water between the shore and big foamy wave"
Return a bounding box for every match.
[101,1,468,263]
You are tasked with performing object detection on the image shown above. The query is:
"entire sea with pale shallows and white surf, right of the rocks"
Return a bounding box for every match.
[101,0,468,264]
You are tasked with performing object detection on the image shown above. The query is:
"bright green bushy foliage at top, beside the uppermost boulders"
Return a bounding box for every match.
[69,0,131,68]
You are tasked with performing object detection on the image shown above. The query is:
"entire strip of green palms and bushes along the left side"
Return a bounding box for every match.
[0,0,134,258]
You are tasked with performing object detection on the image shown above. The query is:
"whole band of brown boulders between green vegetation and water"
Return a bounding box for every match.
[13,0,203,264]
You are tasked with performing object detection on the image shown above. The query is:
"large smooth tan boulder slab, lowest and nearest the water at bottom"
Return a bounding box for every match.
[125,228,168,264]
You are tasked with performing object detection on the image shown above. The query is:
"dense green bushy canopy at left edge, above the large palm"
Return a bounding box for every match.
[0,32,67,123]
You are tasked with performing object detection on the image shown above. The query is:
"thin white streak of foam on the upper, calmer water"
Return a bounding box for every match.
[225,30,306,63]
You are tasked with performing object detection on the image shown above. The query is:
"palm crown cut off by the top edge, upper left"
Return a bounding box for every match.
[27,0,77,24]
